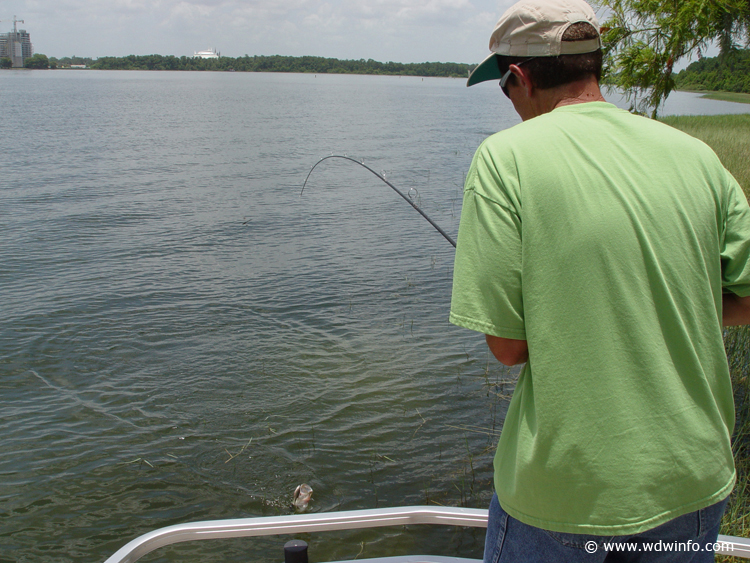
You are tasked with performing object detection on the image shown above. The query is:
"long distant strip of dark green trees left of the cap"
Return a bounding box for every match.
[85,55,472,77]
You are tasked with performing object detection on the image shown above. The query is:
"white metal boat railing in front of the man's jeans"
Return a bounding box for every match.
[105,506,750,563]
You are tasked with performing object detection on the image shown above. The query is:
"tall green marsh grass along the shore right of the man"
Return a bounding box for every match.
[662,115,750,563]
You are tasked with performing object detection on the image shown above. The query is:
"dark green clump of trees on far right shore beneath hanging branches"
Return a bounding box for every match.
[675,49,750,93]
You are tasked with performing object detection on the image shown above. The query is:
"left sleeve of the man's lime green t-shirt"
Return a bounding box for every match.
[450,147,526,340]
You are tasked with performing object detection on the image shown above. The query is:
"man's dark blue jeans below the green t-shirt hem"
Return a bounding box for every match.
[484,495,727,563]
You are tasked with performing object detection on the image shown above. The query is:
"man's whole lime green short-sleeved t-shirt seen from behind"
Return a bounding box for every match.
[450,102,750,535]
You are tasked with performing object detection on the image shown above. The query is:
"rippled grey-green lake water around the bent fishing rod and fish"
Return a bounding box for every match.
[0,71,750,563]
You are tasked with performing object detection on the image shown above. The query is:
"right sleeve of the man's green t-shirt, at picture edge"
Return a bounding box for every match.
[721,172,750,297]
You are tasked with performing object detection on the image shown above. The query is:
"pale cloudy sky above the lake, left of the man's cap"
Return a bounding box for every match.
[0,0,544,64]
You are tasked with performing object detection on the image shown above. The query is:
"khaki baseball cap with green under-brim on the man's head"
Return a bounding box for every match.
[466,0,602,86]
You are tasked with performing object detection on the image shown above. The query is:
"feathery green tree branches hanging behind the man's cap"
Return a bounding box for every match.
[597,0,750,117]
